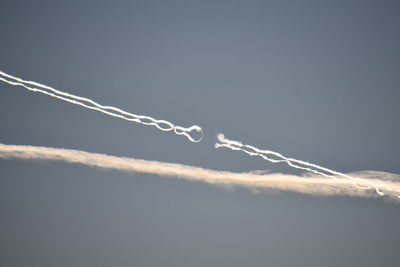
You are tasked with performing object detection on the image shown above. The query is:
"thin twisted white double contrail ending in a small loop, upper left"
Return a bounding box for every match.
[0,71,203,142]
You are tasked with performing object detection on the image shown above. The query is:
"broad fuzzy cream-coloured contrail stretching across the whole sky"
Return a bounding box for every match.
[0,144,400,201]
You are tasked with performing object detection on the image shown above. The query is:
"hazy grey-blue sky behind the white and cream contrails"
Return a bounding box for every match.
[0,0,400,267]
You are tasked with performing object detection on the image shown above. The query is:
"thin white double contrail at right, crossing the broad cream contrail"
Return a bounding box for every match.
[215,134,400,198]
